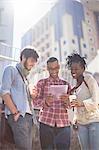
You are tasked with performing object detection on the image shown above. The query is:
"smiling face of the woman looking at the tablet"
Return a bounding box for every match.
[71,62,85,79]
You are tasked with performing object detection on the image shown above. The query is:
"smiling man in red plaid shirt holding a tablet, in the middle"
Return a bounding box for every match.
[33,57,70,150]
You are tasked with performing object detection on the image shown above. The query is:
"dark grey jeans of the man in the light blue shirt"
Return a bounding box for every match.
[8,114,33,150]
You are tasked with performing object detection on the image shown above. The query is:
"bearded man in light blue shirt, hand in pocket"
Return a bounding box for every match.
[0,48,39,150]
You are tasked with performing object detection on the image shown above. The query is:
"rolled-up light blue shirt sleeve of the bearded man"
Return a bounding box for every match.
[0,66,14,96]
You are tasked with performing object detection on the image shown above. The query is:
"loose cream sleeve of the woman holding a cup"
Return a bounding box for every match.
[83,76,99,111]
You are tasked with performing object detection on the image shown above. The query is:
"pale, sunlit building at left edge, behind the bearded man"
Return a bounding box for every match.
[0,0,14,84]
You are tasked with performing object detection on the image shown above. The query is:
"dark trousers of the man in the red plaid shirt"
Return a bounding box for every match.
[40,123,71,150]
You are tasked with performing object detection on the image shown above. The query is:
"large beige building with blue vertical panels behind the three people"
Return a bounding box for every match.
[22,0,99,82]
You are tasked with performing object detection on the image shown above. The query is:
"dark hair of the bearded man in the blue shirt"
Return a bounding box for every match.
[20,48,39,61]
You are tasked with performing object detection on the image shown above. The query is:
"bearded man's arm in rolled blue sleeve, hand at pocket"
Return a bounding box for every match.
[0,66,19,120]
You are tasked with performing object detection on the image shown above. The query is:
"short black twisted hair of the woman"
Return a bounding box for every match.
[66,53,87,69]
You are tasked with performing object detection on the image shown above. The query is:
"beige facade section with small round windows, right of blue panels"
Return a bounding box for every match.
[81,0,99,62]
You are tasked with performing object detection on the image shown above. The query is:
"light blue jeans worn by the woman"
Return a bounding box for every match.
[78,122,99,150]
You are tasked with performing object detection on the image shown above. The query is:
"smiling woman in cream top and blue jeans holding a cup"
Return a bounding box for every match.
[66,53,99,150]
